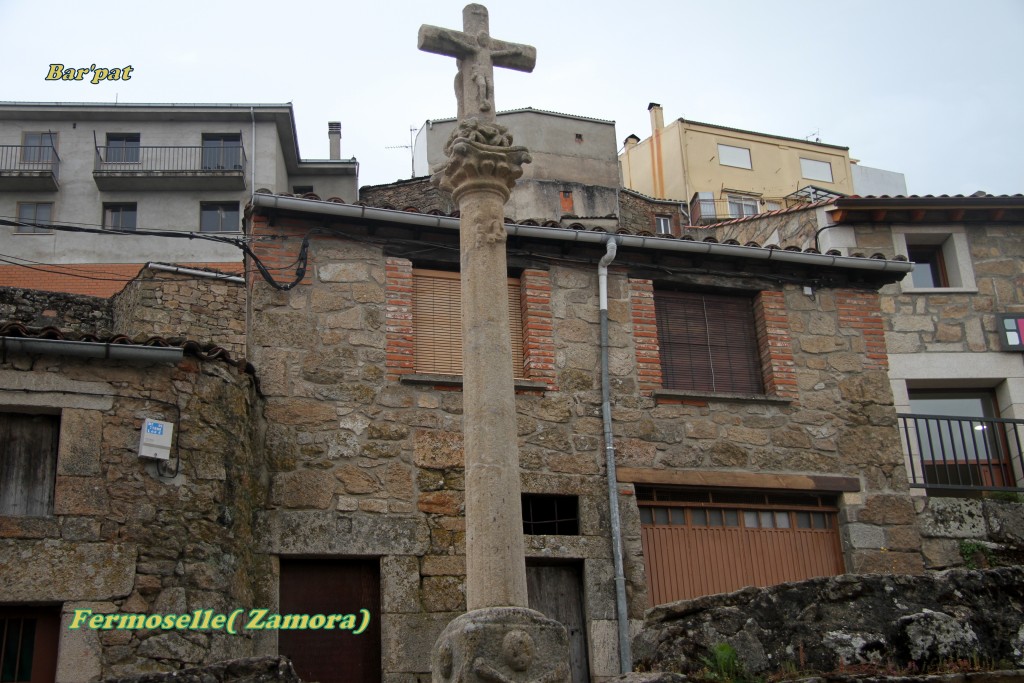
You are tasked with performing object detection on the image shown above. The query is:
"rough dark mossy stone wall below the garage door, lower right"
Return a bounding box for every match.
[634,567,1024,680]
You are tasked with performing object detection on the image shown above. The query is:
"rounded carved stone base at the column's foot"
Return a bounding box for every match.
[431,607,569,683]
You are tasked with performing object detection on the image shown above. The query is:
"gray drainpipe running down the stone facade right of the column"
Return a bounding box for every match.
[597,238,633,674]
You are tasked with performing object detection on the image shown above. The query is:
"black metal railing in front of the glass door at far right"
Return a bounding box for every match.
[897,414,1024,495]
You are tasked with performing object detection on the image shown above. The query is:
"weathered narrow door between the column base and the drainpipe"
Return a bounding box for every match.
[526,564,590,683]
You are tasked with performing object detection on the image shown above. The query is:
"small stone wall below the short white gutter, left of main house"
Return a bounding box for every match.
[112,268,246,357]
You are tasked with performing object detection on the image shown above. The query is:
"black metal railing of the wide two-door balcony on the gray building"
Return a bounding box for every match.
[94,145,246,173]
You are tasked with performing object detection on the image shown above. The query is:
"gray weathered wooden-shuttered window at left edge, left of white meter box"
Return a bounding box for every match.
[0,413,60,517]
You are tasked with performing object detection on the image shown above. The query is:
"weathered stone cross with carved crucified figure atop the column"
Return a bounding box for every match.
[419,4,537,122]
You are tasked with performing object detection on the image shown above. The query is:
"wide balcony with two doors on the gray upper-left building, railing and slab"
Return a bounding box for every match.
[92,145,246,191]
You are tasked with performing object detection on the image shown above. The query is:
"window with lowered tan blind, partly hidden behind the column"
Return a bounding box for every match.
[413,268,524,378]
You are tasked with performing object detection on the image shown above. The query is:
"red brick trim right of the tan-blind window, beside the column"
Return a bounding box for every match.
[519,270,558,391]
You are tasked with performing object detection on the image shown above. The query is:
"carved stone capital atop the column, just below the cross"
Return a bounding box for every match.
[431,119,532,204]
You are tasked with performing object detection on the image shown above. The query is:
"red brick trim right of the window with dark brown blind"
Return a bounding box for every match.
[754,291,800,401]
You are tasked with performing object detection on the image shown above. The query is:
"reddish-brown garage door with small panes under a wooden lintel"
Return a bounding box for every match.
[637,486,843,605]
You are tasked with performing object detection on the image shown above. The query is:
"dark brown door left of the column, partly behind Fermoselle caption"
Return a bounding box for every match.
[278,558,381,683]
